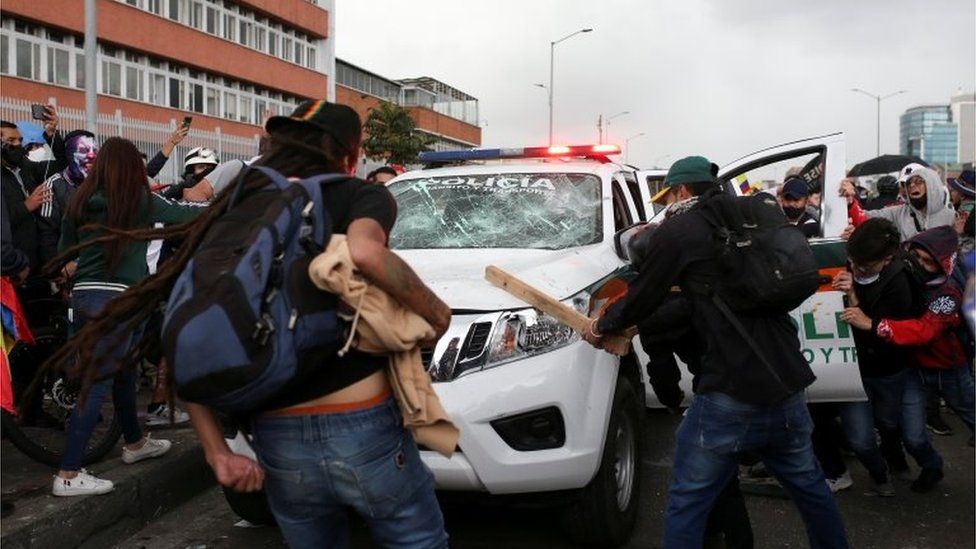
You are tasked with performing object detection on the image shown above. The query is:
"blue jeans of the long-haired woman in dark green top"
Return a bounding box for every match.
[61,290,143,471]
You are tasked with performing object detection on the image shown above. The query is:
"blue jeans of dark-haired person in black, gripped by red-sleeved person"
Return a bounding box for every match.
[840,370,908,484]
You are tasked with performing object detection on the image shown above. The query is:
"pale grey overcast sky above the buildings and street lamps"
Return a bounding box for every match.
[335,0,976,167]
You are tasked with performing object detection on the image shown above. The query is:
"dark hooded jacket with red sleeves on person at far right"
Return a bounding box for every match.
[868,227,967,370]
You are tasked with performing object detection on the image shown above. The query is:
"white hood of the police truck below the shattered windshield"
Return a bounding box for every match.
[395,244,623,311]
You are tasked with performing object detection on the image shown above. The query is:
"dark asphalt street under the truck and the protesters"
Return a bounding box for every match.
[118,412,976,549]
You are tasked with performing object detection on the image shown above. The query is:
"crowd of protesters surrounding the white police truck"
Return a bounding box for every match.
[0,101,976,547]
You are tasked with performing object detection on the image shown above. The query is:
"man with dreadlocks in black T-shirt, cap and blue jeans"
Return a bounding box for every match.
[45,100,451,547]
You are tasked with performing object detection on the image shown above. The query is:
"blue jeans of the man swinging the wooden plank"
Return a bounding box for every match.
[664,393,848,549]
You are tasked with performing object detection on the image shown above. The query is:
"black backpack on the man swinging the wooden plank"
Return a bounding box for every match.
[698,193,820,313]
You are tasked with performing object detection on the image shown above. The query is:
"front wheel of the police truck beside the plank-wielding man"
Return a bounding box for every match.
[563,375,643,547]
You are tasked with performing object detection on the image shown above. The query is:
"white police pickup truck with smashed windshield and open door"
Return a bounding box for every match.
[388,134,863,546]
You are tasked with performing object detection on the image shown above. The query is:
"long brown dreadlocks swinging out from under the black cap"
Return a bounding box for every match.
[37,123,359,404]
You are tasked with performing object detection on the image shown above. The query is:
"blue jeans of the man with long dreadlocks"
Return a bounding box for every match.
[253,399,447,549]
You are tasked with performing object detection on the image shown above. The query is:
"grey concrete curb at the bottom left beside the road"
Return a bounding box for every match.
[0,431,215,549]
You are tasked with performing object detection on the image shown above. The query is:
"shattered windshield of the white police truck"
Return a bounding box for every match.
[389,173,603,250]
